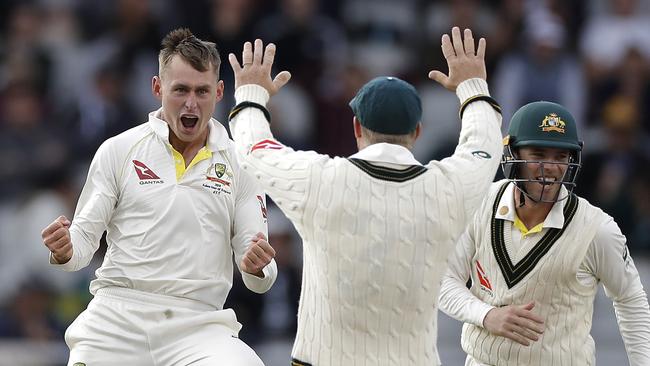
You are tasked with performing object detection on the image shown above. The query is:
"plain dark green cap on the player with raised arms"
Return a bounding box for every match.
[350,76,422,135]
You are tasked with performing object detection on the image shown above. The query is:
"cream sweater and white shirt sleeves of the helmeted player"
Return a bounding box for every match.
[440,181,650,366]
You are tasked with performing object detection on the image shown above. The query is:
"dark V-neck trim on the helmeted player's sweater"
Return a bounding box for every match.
[490,182,578,288]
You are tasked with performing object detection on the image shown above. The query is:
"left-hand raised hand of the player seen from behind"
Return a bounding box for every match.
[228,39,291,96]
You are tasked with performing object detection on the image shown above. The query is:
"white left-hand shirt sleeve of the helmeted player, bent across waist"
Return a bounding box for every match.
[439,210,494,327]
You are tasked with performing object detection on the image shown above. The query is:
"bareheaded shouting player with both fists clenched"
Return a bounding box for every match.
[42,29,277,366]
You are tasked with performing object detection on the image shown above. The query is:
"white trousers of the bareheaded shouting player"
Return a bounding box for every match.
[65,287,264,366]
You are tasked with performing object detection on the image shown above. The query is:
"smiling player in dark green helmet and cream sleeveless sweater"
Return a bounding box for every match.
[440,102,650,366]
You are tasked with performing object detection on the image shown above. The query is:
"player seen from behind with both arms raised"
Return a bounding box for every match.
[230,28,501,366]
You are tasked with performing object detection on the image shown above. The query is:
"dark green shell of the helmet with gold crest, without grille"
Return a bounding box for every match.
[504,102,582,151]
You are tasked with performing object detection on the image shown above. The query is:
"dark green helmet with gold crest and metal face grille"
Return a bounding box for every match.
[501,101,582,202]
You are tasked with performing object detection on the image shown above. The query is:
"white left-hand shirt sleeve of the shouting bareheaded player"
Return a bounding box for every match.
[50,140,119,271]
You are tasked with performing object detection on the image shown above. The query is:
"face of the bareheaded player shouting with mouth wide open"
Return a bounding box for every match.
[152,55,223,148]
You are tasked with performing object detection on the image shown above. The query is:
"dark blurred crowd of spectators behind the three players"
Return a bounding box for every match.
[0,0,650,362]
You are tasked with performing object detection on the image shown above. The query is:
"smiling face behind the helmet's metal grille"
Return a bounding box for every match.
[518,147,571,201]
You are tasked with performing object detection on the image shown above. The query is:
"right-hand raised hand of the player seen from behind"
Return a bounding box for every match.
[429,27,487,91]
